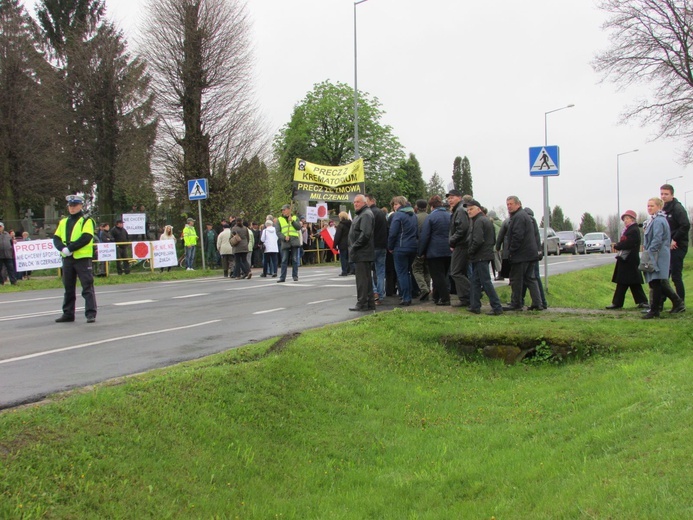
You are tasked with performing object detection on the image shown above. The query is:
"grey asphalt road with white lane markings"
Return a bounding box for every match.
[0,254,614,409]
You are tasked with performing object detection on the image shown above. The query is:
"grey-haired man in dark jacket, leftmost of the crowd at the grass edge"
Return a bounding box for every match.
[349,194,375,311]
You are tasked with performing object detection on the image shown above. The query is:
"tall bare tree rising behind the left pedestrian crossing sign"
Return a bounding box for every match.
[140,0,263,207]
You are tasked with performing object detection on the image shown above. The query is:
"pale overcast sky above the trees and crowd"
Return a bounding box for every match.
[27,0,693,226]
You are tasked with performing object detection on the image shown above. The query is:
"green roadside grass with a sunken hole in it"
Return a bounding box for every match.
[0,263,693,520]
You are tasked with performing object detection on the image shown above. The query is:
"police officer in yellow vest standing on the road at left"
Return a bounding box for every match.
[53,195,96,323]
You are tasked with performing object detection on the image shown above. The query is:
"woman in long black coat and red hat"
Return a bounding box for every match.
[606,209,648,309]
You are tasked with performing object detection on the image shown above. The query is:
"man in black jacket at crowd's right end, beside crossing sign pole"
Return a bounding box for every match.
[503,195,542,311]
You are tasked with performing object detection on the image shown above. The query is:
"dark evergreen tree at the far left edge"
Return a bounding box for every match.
[0,0,67,221]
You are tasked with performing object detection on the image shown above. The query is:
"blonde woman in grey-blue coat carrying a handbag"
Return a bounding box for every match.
[638,197,686,320]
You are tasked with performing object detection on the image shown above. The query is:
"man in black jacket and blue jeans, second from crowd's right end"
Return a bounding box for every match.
[466,200,503,316]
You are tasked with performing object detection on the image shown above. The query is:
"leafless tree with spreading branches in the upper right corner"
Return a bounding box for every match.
[593,0,693,163]
